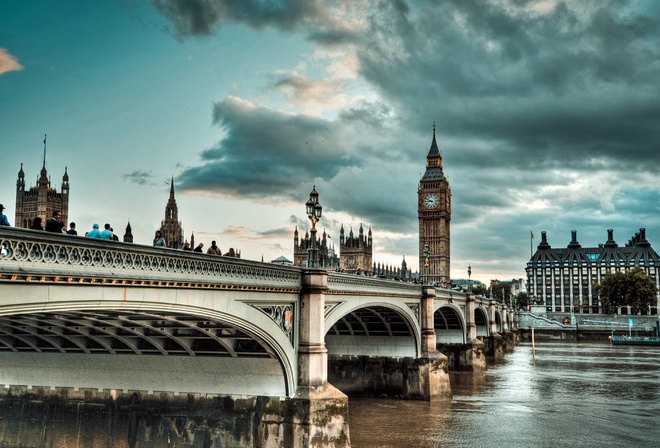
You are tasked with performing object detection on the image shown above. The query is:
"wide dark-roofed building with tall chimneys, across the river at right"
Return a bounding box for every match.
[526,229,660,314]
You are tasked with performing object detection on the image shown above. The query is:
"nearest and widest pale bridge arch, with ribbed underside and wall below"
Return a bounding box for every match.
[0,285,297,396]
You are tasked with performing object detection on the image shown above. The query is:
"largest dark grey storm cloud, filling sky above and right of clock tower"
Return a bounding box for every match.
[358,0,660,170]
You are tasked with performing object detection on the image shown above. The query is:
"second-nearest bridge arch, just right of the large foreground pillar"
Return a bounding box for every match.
[325,299,421,357]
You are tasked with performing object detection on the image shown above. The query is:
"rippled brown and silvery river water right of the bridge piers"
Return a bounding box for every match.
[349,343,660,448]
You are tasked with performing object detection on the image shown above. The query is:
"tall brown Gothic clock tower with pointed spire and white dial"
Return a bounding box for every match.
[417,123,451,288]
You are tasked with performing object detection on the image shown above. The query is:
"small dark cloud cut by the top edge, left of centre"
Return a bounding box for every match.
[149,0,327,37]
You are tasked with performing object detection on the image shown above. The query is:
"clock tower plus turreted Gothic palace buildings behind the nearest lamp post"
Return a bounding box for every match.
[293,124,451,288]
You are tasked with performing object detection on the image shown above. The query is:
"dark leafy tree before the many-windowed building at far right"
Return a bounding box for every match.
[594,266,658,314]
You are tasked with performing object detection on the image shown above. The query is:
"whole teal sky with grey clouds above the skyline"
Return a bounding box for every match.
[0,0,660,282]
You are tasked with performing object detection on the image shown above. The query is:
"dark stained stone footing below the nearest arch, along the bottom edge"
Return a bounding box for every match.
[0,387,350,448]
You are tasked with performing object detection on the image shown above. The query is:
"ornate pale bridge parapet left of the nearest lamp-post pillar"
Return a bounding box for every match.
[0,227,302,291]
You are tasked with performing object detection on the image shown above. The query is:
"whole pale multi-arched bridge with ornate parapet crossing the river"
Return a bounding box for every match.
[0,227,513,446]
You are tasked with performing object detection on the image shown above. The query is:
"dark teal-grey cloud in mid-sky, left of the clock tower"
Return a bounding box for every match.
[179,97,361,198]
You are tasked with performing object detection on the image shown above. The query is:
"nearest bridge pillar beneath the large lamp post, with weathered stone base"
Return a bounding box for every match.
[294,269,350,448]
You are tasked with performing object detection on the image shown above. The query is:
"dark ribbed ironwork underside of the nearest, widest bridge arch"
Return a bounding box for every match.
[0,310,276,358]
